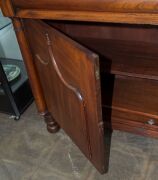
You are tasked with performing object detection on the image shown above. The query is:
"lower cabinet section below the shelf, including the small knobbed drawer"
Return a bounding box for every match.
[103,76,158,137]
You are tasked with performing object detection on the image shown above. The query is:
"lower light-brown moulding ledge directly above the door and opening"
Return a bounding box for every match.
[13,9,158,25]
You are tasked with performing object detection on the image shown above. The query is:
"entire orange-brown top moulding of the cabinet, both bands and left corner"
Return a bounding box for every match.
[1,0,158,25]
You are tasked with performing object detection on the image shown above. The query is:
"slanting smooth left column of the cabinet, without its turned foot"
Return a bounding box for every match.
[12,18,47,115]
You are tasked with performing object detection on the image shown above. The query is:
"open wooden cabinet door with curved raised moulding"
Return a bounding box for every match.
[24,20,106,173]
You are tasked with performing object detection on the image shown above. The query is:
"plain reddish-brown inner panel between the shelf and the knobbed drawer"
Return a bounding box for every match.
[102,76,158,116]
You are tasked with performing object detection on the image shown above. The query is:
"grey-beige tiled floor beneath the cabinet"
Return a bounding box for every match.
[0,104,158,180]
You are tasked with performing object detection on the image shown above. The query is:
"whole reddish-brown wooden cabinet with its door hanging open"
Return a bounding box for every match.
[1,0,158,173]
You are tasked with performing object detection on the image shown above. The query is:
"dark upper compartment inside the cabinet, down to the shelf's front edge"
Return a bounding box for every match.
[48,22,158,80]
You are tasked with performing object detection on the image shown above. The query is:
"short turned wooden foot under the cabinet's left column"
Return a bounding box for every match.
[44,112,60,133]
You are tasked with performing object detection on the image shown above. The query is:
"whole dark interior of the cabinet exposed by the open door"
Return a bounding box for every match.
[46,21,158,134]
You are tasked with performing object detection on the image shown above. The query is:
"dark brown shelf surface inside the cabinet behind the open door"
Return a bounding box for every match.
[78,38,158,80]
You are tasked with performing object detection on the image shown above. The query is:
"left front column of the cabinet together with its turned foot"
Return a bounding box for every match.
[12,18,60,133]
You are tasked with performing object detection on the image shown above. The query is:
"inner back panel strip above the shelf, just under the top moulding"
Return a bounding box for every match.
[49,20,158,43]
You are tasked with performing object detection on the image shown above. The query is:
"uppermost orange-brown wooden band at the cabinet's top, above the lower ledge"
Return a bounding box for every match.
[12,0,158,13]
